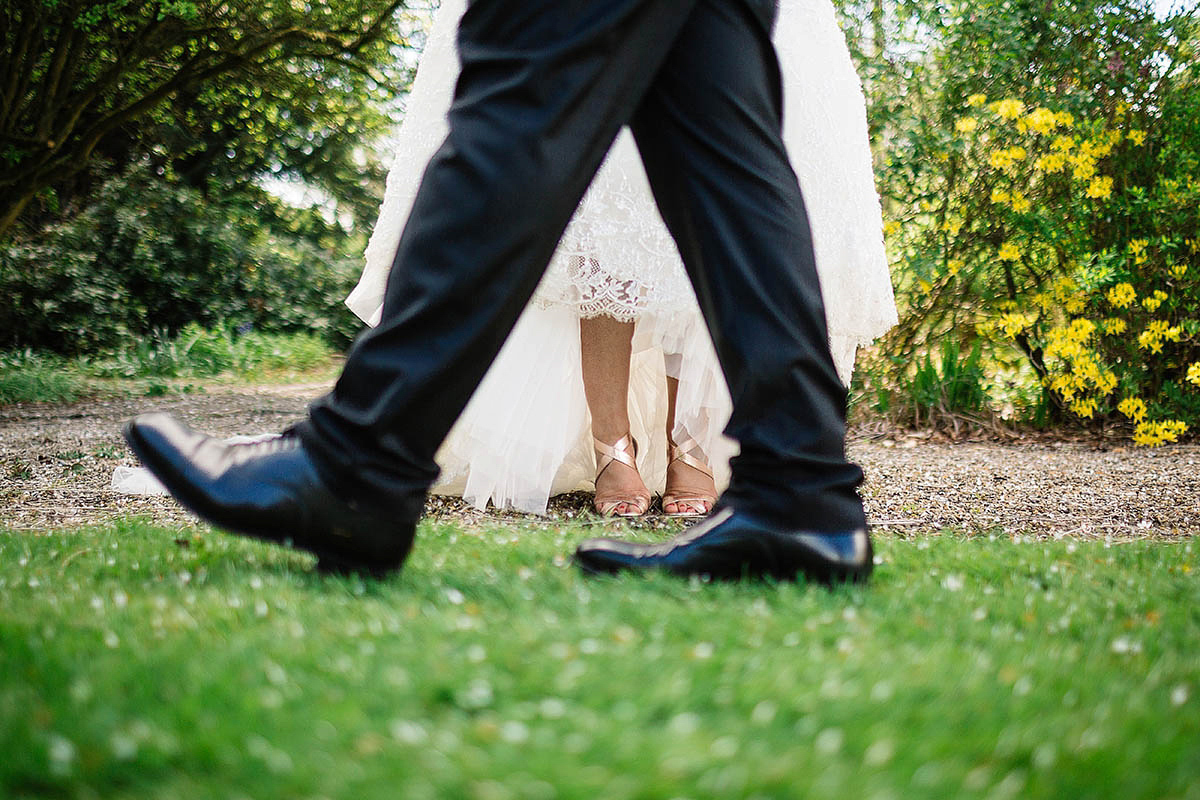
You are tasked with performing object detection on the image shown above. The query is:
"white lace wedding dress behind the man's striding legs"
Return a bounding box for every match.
[346,0,896,513]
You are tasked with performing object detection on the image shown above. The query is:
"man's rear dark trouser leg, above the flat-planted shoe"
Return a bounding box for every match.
[632,0,865,533]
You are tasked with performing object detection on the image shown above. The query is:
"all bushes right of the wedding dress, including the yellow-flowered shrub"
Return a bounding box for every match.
[844,0,1200,444]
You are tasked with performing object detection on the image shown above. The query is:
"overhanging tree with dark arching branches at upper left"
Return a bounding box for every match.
[0,0,412,240]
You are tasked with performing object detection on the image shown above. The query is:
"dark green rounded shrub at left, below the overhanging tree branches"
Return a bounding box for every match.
[0,165,359,354]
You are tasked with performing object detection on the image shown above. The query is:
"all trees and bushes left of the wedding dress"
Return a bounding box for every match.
[0,0,420,354]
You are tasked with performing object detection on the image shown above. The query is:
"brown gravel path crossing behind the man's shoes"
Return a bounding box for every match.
[0,384,1200,541]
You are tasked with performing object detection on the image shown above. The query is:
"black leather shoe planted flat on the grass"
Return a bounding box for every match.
[575,509,874,584]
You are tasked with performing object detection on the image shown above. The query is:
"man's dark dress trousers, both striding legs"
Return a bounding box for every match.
[299,0,864,531]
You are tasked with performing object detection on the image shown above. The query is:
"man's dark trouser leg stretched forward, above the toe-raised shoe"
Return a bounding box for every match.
[300,0,695,505]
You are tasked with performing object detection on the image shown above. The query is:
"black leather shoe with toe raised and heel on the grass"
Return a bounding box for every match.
[124,414,425,576]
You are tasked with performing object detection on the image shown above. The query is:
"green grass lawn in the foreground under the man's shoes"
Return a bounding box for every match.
[0,522,1200,800]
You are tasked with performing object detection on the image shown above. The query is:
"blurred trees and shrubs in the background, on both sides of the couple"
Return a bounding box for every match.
[0,0,1200,445]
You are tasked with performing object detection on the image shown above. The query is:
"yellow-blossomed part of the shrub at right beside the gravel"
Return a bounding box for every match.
[883,86,1200,446]
